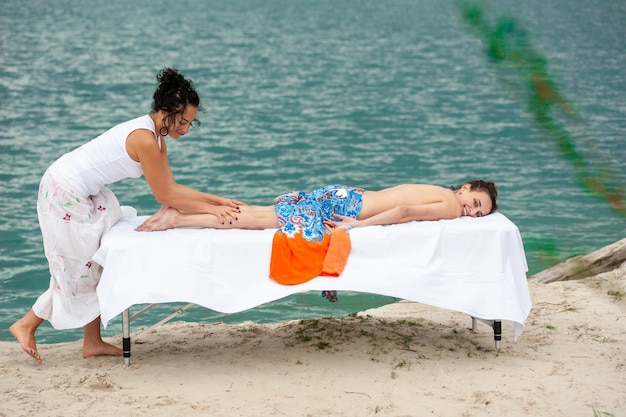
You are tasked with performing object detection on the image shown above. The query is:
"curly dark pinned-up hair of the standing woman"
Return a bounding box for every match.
[152,68,200,132]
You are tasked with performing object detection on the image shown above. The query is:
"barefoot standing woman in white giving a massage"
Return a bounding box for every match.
[10,68,245,362]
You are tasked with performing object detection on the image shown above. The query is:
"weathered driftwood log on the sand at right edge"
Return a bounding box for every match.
[528,238,626,283]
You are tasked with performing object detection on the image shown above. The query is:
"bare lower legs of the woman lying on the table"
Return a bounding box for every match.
[137,206,278,232]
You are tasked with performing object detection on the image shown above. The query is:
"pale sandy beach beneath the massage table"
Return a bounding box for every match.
[0,264,626,417]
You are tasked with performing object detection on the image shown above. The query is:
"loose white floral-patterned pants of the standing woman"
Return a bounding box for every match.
[33,172,121,329]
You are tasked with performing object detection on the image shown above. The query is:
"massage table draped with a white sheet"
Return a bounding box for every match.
[94,207,531,365]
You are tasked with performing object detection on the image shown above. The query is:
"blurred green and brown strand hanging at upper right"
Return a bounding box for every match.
[458,1,626,217]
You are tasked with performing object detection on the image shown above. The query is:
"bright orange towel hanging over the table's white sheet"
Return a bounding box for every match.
[270,228,352,285]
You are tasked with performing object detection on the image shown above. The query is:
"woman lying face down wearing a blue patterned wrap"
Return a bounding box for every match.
[137,180,498,231]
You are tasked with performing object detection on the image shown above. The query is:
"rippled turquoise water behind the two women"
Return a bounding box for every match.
[0,0,626,342]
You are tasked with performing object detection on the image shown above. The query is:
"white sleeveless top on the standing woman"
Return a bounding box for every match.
[48,115,161,196]
